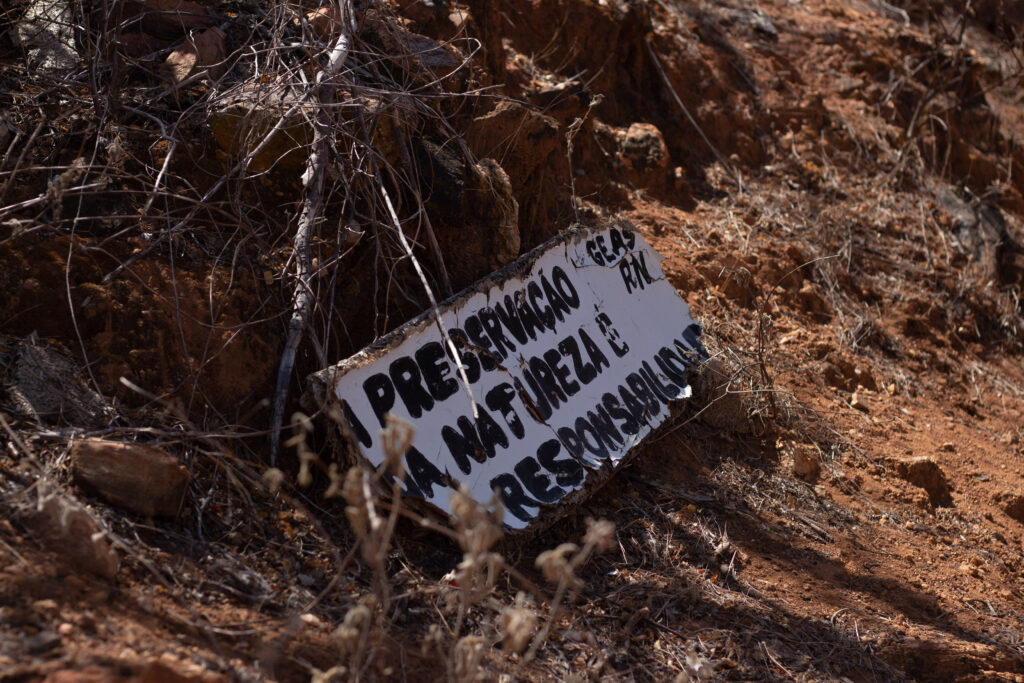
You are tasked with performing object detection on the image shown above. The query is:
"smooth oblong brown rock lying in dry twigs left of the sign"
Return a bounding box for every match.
[71,438,188,517]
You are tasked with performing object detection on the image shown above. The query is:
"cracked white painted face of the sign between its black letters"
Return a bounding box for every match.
[334,228,703,528]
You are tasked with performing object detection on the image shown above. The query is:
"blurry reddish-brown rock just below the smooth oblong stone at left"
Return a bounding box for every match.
[22,494,119,580]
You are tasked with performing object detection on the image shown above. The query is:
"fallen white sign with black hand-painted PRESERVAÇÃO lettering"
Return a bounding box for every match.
[309,227,708,528]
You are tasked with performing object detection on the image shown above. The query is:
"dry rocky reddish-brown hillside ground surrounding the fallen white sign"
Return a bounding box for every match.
[0,0,1024,683]
